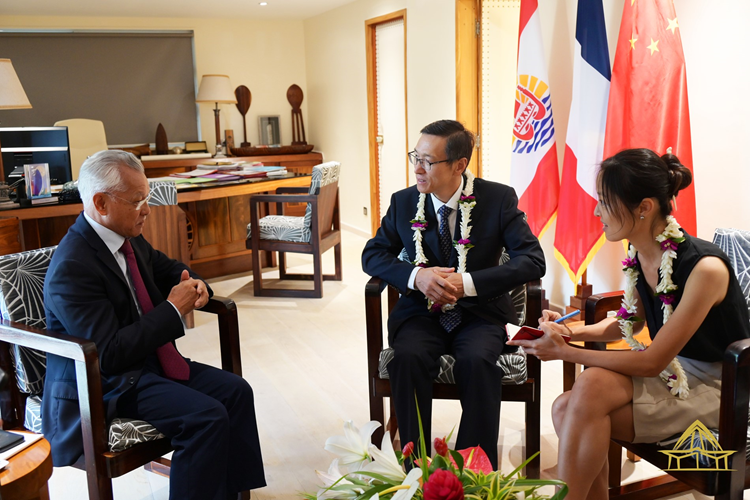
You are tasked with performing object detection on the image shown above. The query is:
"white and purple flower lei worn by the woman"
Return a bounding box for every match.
[617,215,690,399]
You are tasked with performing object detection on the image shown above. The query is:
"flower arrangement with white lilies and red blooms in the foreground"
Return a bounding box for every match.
[304,421,568,500]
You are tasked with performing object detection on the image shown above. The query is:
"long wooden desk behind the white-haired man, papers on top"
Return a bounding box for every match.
[0,174,311,278]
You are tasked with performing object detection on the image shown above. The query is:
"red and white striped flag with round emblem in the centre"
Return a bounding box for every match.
[510,0,560,237]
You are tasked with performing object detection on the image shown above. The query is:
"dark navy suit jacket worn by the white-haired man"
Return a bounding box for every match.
[42,214,211,467]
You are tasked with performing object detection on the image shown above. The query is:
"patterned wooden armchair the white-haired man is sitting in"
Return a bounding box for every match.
[0,241,242,499]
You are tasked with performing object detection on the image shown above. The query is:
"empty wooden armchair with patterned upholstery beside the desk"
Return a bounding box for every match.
[245,162,341,299]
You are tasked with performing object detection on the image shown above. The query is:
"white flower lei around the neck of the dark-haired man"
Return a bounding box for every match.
[411,169,477,311]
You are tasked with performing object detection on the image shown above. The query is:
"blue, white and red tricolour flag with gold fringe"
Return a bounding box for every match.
[555,0,612,283]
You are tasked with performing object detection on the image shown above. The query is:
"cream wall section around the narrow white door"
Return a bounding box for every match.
[304,0,456,234]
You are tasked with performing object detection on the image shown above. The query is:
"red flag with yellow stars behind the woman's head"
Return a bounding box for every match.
[604,0,696,234]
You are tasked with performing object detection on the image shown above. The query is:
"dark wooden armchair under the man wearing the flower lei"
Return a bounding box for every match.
[365,278,546,478]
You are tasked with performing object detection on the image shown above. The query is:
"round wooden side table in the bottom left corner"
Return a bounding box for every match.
[0,438,52,500]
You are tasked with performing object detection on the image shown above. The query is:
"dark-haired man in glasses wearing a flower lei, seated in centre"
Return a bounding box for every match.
[362,120,545,469]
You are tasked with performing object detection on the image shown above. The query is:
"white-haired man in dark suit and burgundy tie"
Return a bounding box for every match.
[42,151,266,500]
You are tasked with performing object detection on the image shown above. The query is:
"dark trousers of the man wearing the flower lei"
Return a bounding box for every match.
[388,312,506,470]
